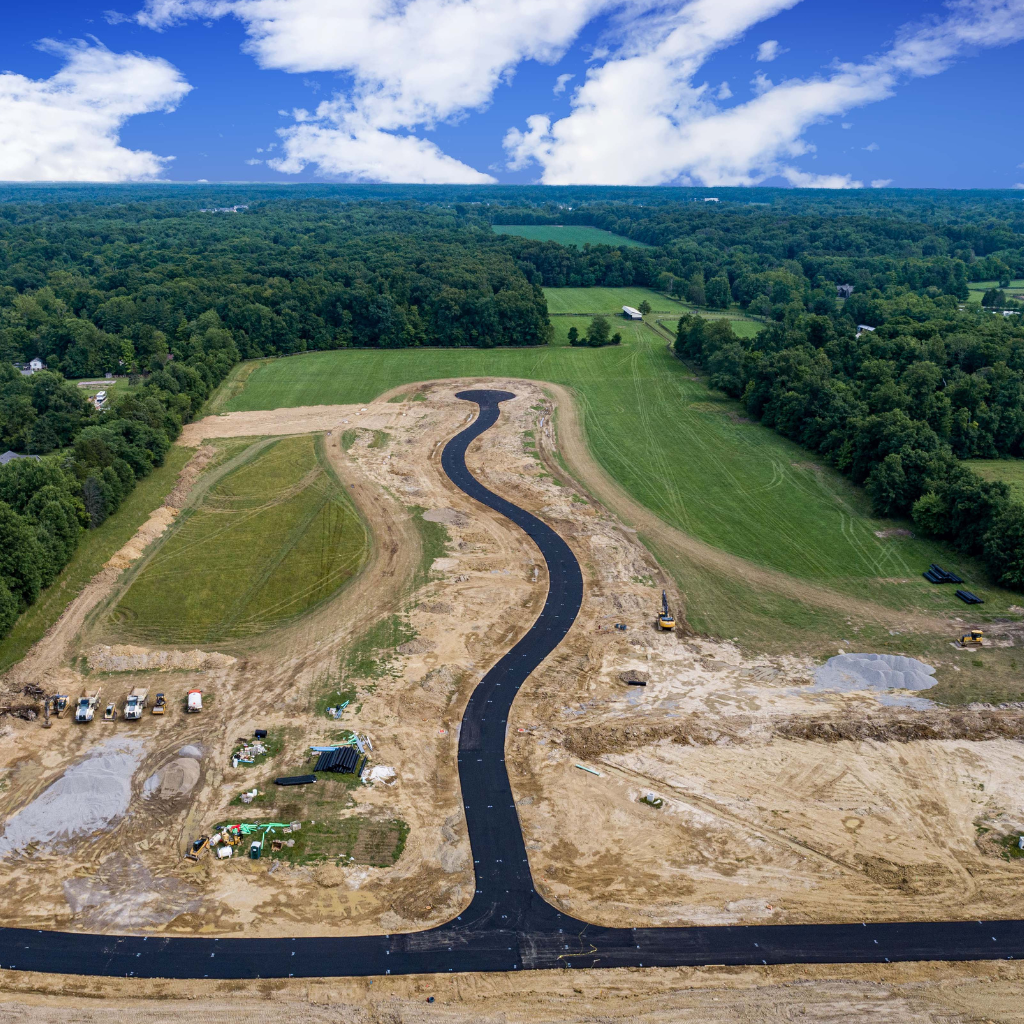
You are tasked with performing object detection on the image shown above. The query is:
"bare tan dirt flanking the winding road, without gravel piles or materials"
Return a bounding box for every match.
[0,381,1024,958]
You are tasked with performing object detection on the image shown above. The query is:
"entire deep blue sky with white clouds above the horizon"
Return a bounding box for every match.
[0,0,1024,188]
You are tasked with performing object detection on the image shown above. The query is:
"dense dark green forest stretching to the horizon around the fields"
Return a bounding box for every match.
[0,185,1024,635]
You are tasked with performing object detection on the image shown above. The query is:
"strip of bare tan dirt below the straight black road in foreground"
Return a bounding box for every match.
[0,962,1024,1024]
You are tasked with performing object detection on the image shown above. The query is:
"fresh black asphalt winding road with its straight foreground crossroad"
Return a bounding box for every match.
[0,390,1024,978]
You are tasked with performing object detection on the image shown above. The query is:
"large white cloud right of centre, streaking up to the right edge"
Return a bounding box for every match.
[505,0,1024,187]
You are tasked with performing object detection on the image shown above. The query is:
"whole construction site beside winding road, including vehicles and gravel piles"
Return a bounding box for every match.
[0,380,1024,1019]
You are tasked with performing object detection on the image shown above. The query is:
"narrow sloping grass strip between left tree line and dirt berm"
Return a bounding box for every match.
[0,445,193,672]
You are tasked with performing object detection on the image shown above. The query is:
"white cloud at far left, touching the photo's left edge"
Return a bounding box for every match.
[0,40,191,181]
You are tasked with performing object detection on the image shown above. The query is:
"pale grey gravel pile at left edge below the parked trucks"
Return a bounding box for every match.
[0,738,142,857]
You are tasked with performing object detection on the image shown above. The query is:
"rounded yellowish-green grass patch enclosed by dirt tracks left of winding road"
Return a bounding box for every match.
[109,436,368,643]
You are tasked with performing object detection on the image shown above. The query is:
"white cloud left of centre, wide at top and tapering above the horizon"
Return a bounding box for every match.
[129,0,614,182]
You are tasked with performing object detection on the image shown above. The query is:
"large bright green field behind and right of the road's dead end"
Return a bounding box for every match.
[218,322,1017,671]
